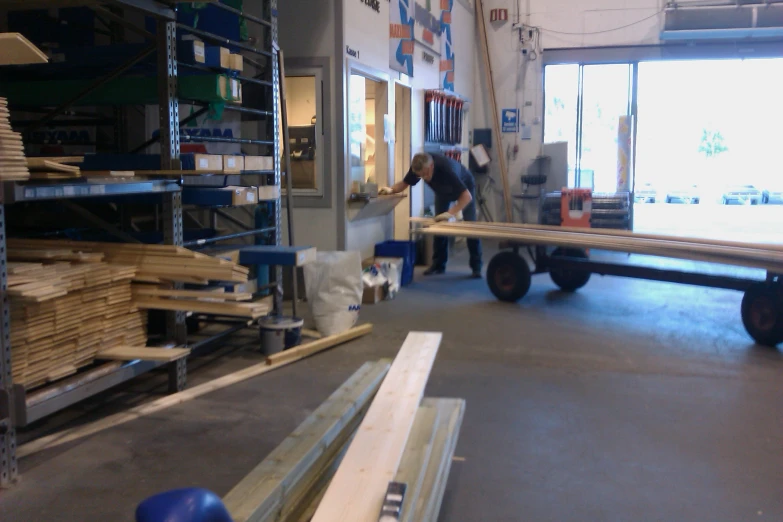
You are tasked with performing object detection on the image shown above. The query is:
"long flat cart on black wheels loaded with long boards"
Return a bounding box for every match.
[416,220,783,346]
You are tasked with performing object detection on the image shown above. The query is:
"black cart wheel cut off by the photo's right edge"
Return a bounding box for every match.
[742,283,783,346]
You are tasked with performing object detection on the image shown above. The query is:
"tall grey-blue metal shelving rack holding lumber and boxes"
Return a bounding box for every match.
[0,0,282,488]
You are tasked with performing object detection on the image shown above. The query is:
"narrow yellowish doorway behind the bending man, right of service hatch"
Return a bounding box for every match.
[394,83,412,241]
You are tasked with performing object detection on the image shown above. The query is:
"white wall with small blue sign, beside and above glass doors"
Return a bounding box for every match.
[472,0,664,219]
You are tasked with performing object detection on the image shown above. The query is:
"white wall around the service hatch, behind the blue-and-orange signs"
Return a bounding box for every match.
[344,0,475,256]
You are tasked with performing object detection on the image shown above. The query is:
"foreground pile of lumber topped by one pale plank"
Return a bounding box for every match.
[224,333,465,522]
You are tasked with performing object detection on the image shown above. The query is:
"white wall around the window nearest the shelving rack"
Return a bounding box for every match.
[278,0,345,250]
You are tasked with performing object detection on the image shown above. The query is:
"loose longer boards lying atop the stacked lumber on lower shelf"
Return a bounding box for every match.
[8,239,272,319]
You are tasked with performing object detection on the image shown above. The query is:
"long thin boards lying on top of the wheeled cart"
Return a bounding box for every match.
[414,220,783,273]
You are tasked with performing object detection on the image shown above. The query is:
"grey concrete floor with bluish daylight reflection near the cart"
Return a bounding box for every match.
[0,250,783,522]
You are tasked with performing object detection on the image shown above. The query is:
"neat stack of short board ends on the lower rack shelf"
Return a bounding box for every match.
[8,260,147,388]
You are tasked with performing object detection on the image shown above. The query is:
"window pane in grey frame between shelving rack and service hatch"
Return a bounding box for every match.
[281,69,324,195]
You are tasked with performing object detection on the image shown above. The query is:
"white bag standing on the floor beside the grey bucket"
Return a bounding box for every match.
[304,252,362,336]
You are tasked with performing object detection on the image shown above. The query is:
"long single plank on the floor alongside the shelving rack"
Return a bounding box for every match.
[16,318,374,458]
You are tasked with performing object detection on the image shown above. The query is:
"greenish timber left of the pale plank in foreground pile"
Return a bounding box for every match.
[223,362,389,522]
